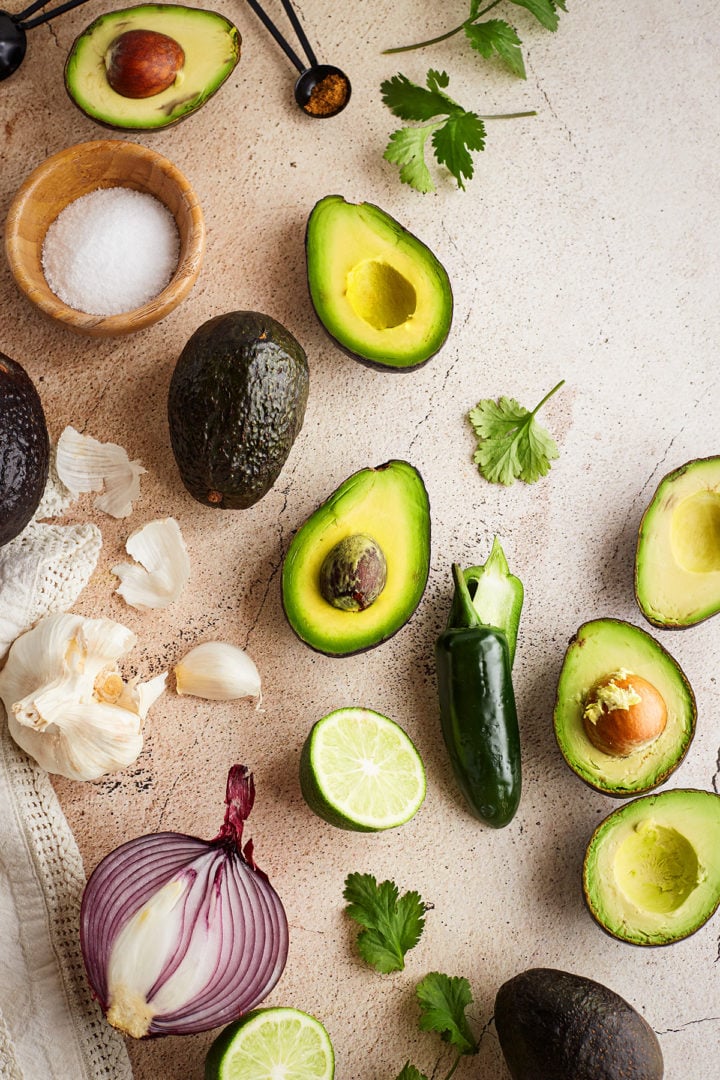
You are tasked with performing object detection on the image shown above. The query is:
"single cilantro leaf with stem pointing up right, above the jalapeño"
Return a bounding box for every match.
[467,379,565,485]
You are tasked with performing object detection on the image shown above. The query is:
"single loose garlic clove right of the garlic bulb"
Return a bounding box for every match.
[175,642,260,701]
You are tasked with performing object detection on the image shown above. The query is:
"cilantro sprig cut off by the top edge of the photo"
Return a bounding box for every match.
[384,0,568,79]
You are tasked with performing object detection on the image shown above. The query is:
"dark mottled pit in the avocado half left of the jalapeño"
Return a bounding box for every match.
[320,532,388,611]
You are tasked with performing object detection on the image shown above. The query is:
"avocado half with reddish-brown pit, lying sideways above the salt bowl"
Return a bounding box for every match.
[65,3,241,131]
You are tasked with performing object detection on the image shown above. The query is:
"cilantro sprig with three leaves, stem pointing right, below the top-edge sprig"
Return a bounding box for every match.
[380,68,535,192]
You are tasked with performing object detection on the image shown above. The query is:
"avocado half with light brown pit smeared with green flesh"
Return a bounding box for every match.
[554,619,696,798]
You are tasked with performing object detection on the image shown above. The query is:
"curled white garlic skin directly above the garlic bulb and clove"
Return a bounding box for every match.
[112,517,190,609]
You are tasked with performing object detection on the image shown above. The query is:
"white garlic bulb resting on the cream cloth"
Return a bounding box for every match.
[0,613,166,780]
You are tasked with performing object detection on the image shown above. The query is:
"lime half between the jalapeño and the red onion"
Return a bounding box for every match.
[300,708,425,833]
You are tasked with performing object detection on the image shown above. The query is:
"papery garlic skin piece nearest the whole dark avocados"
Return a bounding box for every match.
[55,427,146,517]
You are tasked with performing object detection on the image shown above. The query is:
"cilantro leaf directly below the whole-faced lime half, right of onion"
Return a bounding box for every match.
[343,874,425,974]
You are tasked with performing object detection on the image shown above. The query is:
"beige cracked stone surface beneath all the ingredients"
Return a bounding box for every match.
[0,0,720,1080]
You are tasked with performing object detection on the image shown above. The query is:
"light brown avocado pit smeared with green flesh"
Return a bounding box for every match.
[583,670,667,757]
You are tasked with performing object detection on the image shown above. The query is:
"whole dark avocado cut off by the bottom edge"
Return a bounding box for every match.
[494,968,664,1080]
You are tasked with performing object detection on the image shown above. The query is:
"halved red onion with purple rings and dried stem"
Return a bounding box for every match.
[80,765,288,1039]
